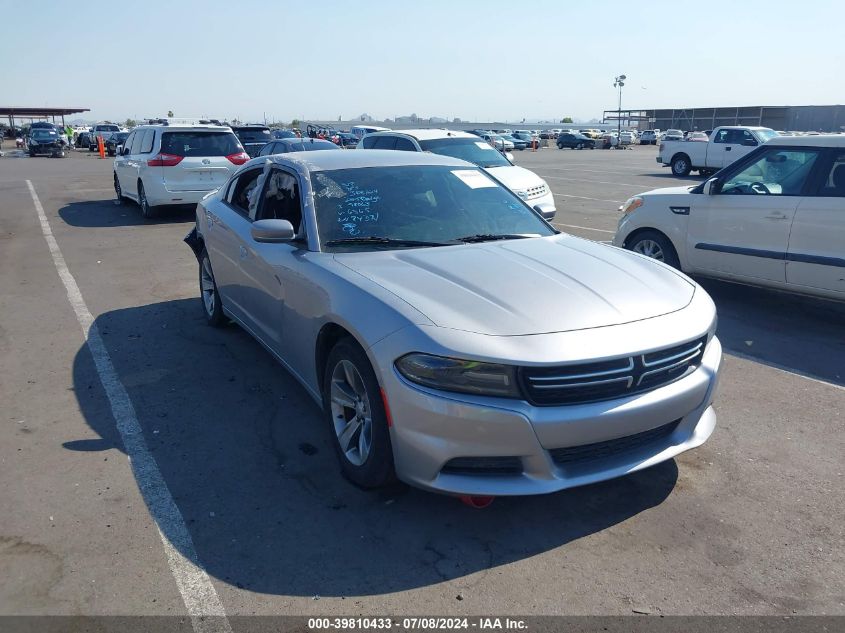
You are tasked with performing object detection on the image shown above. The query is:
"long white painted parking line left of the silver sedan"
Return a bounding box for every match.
[26,180,232,633]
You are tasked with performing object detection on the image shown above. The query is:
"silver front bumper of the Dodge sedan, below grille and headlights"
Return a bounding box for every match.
[374,336,722,496]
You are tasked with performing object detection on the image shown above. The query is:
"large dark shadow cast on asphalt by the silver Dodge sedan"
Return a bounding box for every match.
[69,299,678,596]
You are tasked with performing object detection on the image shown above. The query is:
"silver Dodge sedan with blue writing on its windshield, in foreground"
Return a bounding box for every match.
[186,150,721,496]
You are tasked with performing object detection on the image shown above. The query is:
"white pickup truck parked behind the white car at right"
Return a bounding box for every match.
[657,125,778,176]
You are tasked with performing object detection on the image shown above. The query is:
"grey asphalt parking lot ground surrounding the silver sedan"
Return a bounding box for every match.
[0,142,845,615]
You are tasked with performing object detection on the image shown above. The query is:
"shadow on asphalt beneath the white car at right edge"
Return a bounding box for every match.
[696,278,845,386]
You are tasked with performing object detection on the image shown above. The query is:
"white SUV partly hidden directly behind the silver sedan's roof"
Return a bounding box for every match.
[358,130,556,220]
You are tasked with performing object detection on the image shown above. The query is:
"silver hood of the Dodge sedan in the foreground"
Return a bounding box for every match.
[334,235,695,336]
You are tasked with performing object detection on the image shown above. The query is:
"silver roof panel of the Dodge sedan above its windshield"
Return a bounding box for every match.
[244,146,477,172]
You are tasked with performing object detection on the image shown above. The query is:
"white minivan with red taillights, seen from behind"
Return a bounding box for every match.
[114,124,249,218]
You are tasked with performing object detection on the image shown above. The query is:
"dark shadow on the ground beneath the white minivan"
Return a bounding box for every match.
[59,200,196,228]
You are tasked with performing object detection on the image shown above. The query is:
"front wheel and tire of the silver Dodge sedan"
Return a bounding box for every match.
[323,338,395,488]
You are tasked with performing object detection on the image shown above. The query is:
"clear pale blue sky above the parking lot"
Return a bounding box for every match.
[0,0,845,121]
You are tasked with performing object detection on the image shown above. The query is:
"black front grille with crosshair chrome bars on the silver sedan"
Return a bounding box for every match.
[519,336,707,406]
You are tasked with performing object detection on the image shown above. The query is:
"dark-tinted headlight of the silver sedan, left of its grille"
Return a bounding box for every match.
[396,353,521,398]
